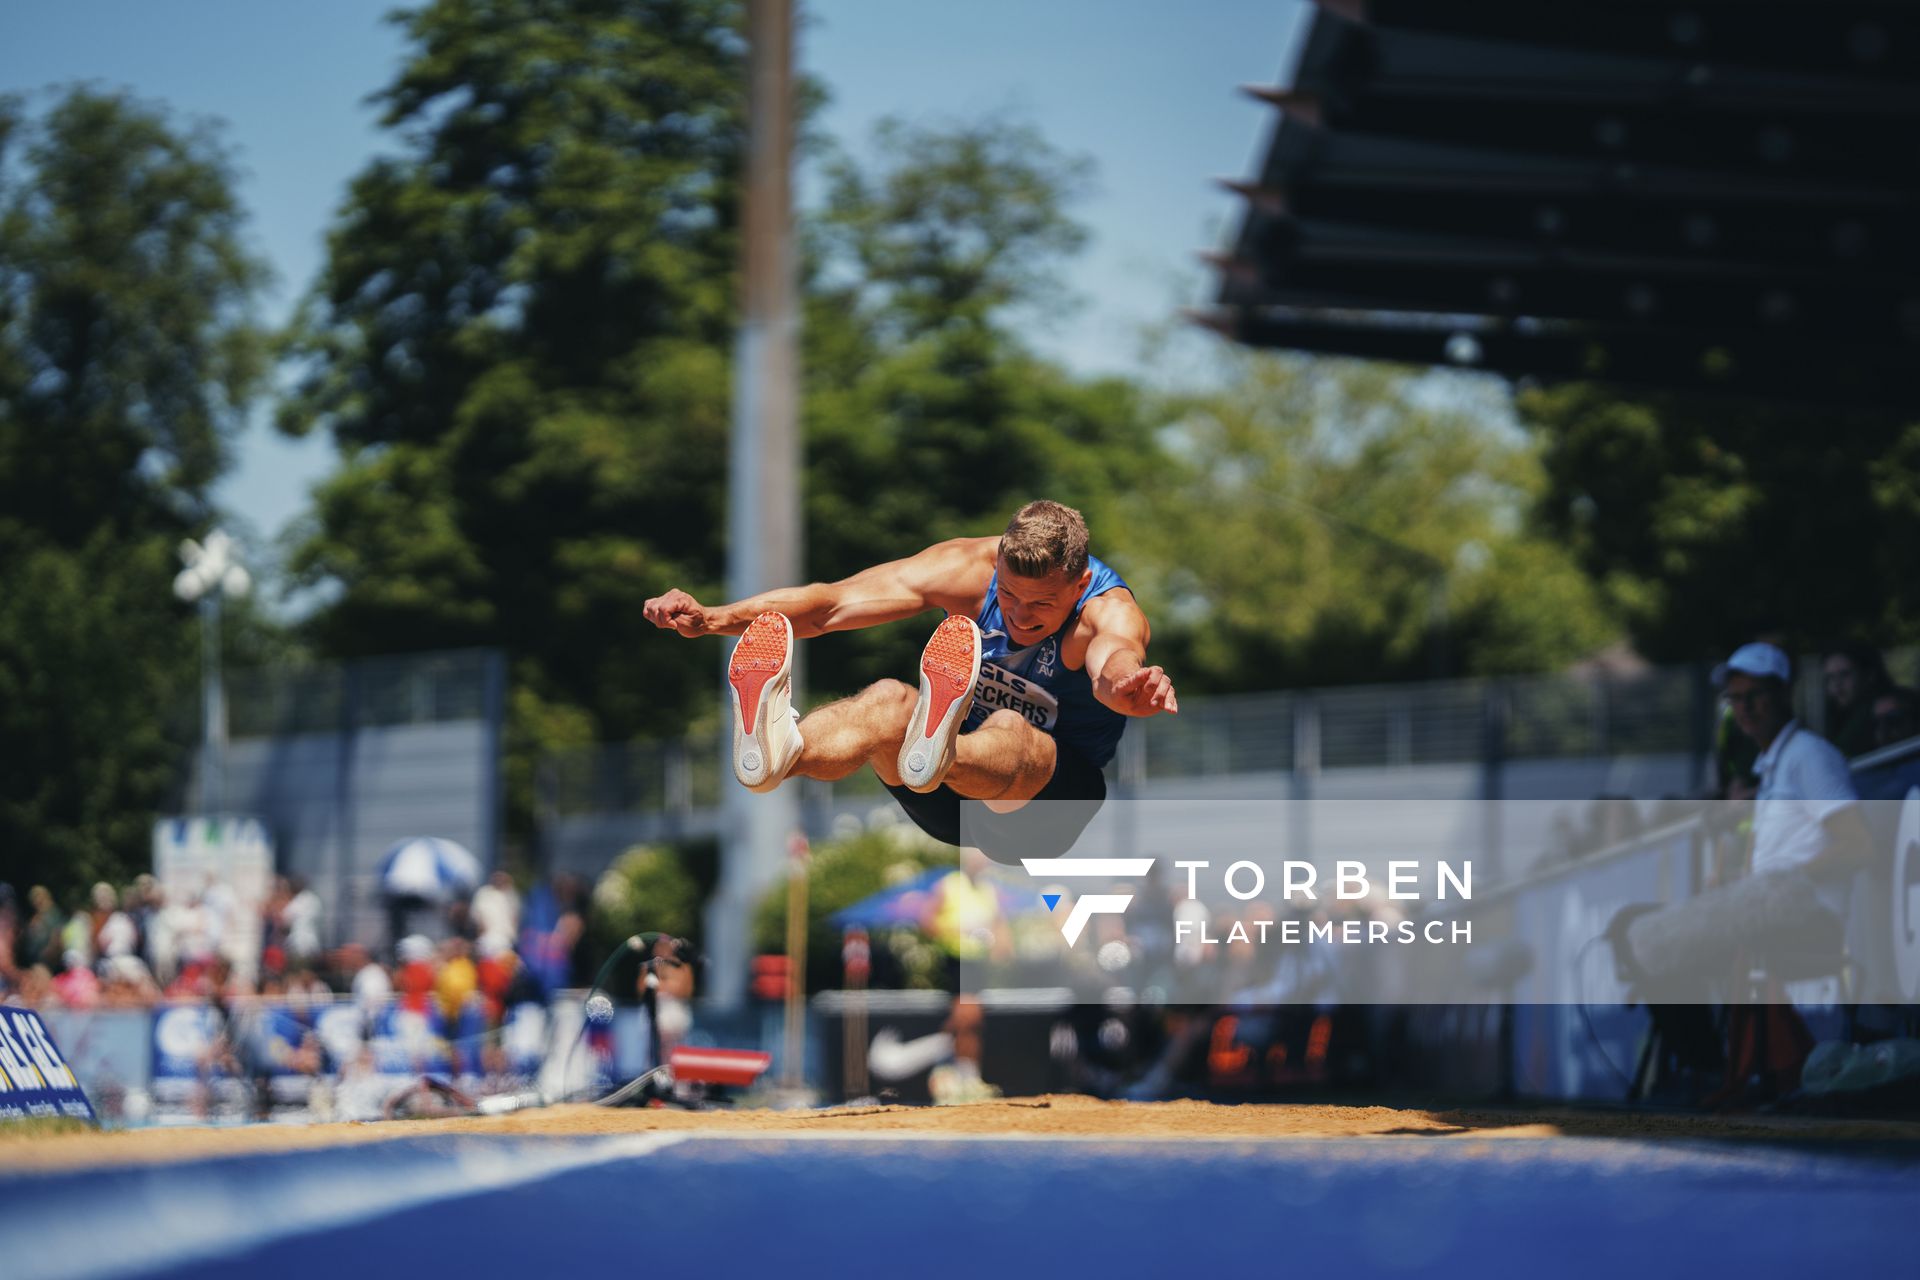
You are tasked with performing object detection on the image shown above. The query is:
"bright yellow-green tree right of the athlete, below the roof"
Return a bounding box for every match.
[1129,351,1613,691]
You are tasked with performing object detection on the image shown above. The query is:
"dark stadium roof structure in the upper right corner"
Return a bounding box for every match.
[1196,0,1920,411]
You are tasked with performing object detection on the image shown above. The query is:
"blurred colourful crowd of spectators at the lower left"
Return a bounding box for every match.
[0,871,625,1119]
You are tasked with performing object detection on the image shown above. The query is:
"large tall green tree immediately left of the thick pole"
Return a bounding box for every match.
[280,0,745,816]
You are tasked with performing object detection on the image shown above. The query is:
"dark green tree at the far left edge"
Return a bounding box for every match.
[0,88,265,889]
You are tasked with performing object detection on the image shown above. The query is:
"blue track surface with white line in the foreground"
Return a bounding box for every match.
[0,1136,1920,1280]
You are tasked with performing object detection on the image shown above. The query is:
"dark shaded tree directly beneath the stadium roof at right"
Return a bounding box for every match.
[1519,384,1920,660]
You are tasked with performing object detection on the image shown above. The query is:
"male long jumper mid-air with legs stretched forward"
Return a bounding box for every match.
[647,501,1179,860]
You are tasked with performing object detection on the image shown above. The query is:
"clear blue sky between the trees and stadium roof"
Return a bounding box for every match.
[0,0,1304,553]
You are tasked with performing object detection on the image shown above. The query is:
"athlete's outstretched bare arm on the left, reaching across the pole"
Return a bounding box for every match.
[645,537,998,639]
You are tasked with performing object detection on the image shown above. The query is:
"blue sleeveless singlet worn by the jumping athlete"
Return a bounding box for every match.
[960,557,1127,768]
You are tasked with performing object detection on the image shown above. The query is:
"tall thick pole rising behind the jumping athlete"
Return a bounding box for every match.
[707,0,803,1007]
